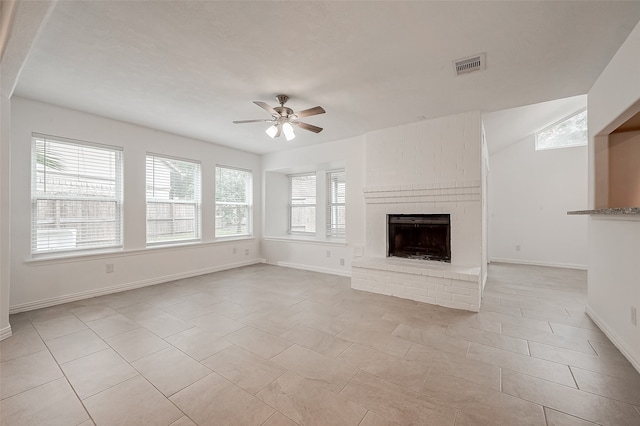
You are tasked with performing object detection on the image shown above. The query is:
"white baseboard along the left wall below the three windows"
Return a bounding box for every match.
[9,259,265,314]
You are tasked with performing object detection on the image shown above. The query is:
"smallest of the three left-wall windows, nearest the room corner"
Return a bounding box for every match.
[216,166,253,237]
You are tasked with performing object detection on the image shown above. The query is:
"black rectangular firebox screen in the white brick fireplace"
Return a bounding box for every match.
[387,214,451,263]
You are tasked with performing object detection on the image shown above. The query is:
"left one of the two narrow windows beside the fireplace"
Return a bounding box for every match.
[289,173,316,234]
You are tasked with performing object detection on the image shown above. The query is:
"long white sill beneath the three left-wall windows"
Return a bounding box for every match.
[24,236,255,266]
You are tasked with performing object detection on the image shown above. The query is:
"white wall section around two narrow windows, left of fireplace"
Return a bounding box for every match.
[262,137,364,275]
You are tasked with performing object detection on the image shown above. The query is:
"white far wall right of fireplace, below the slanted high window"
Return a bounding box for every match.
[489,134,588,269]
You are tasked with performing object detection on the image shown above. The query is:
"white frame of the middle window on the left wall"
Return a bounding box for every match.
[145,152,202,247]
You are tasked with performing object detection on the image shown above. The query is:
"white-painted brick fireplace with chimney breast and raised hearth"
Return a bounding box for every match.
[351,112,483,311]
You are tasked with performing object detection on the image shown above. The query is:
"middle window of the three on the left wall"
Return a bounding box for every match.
[147,154,200,245]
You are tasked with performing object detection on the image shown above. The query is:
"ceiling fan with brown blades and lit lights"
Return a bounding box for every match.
[234,95,326,141]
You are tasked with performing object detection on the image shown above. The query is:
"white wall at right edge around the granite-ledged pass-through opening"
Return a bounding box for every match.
[587,23,640,371]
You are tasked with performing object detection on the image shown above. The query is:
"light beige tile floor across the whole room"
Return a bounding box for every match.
[0,264,640,426]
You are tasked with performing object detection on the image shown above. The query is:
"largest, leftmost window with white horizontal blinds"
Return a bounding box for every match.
[31,134,122,254]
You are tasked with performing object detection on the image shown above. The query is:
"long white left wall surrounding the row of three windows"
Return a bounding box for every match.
[10,98,262,311]
